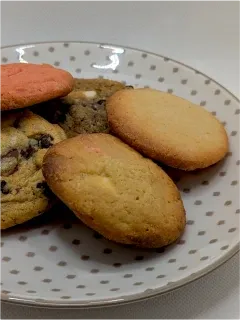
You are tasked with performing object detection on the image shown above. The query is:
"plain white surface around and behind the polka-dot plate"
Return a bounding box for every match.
[0,0,240,320]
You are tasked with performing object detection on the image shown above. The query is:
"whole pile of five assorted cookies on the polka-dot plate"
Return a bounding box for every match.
[0,65,228,248]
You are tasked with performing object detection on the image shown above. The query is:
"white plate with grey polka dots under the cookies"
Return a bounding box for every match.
[0,42,240,307]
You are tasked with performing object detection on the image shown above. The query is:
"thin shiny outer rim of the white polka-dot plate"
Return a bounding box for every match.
[0,40,240,309]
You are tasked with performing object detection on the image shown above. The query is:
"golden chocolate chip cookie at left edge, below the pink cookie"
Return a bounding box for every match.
[0,110,66,229]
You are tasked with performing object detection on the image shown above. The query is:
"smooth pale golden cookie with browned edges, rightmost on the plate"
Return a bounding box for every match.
[106,89,228,171]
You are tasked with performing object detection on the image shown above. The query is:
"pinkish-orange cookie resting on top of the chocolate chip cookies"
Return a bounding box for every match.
[0,63,74,111]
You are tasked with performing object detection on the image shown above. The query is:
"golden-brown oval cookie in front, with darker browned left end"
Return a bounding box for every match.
[43,133,185,248]
